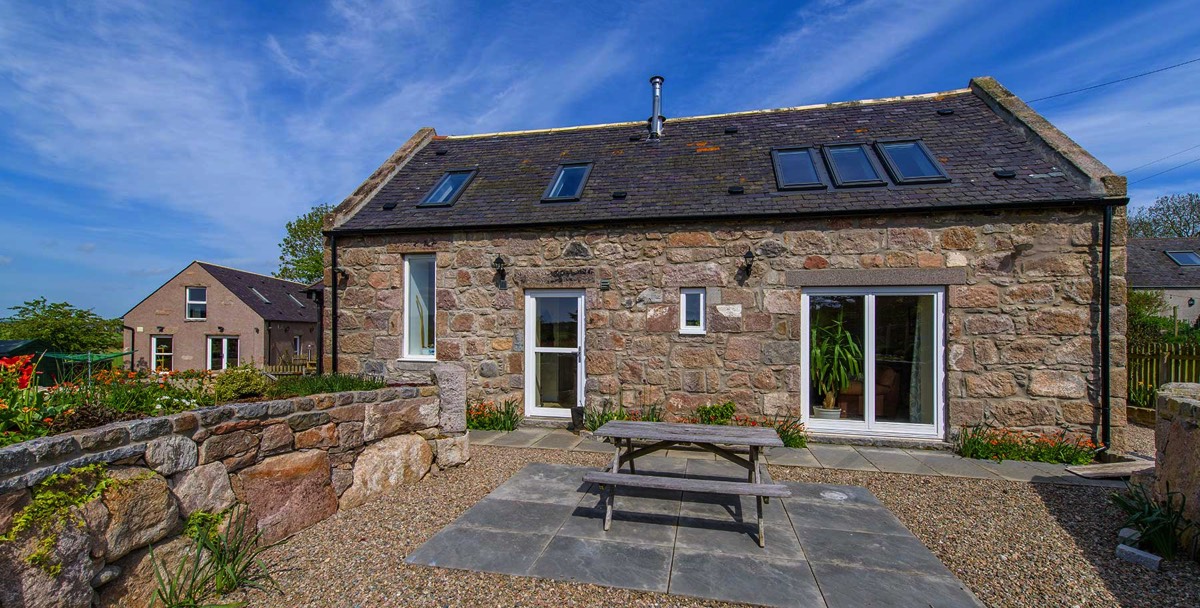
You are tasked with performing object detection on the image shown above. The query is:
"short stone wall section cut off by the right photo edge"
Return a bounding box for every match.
[1154,383,1200,556]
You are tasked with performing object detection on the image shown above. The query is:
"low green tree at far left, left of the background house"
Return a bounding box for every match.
[0,297,121,353]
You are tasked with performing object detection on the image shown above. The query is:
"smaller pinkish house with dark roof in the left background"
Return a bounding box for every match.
[121,261,320,369]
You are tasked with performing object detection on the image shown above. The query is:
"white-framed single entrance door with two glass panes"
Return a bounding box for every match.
[524,290,584,417]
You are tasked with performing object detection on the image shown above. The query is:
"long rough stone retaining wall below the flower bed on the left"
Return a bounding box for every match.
[0,365,469,608]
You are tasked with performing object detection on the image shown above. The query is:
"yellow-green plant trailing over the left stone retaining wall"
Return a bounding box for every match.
[0,464,119,577]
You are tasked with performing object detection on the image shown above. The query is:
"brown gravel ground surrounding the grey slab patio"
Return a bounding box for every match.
[236,446,1200,608]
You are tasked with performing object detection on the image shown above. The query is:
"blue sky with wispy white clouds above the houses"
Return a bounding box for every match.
[0,0,1200,315]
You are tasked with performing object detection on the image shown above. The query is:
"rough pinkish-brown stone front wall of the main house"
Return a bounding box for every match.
[325,209,1126,440]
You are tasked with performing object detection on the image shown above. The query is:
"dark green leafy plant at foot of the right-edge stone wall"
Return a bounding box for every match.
[1109,483,1195,559]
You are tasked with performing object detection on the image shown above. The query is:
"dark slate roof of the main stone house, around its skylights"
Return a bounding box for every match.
[334,89,1102,231]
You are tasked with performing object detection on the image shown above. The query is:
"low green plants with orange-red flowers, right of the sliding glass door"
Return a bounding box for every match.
[954,426,1096,464]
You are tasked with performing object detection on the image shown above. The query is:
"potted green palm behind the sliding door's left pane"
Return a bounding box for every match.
[809,313,863,419]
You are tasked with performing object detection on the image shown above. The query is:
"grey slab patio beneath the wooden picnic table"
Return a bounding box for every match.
[406,460,983,607]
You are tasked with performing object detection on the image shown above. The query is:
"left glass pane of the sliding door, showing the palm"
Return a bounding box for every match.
[809,295,866,421]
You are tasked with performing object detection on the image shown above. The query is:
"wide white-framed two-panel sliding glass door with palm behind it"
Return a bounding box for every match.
[800,287,946,437]
